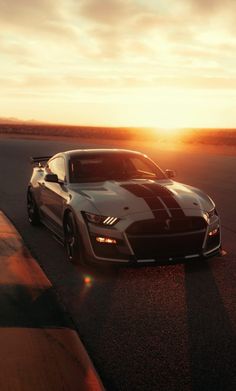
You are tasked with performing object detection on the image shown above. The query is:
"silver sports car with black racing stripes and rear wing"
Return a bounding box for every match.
[27,149,221,264]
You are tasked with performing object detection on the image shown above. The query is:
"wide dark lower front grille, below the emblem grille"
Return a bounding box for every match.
[127,230,205,259]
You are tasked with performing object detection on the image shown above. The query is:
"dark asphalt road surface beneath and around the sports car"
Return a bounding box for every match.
[0,139,236,391]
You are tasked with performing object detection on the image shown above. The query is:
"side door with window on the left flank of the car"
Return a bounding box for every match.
[40,156,67,235]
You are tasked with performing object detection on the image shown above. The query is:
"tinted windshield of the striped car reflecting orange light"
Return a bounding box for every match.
[70,153,166,183]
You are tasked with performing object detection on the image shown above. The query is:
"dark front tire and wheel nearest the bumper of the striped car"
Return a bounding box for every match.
[64,212,84,264]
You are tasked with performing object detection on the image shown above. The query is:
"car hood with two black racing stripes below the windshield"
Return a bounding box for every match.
[69,179,215,217]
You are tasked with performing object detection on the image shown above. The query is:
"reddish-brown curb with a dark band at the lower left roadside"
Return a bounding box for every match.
[0,211,104,391]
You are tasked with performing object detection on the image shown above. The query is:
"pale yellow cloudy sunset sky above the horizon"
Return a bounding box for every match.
[0,0,236,128]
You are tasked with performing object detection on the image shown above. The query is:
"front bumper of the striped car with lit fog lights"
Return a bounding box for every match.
[81,217,221,264]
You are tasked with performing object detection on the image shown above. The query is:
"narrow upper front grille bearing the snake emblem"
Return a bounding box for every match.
[126,217,206,235]
